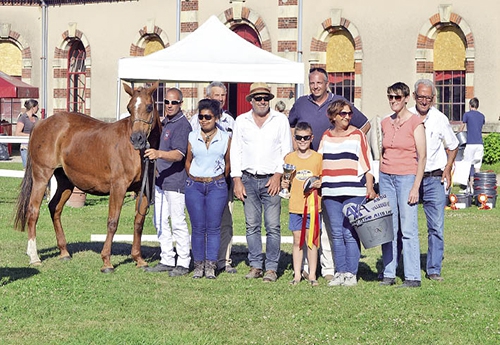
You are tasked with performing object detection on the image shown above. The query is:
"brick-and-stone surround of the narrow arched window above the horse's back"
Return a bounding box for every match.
[52,23,92,115]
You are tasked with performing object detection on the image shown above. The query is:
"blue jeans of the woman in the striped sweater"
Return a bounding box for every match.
[323,196,364,275]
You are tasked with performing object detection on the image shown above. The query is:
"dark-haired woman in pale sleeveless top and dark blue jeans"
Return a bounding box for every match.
[186,99,231,279]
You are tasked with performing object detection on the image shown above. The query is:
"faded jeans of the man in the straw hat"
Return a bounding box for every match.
[241,175,281,271]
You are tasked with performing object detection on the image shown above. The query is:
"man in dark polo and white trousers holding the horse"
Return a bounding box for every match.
[144,88,191,277]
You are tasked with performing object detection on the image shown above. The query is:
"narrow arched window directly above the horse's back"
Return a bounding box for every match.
[66,39,87,114]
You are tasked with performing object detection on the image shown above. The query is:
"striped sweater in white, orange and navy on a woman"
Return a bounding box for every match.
[318,129,371,197]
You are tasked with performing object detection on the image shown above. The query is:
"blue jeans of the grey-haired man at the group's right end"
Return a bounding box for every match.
[420,176,446,274]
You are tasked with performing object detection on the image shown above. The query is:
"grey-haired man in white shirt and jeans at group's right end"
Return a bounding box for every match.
[409,79,458,281]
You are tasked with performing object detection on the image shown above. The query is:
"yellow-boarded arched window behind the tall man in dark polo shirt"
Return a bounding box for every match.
[326,28,355,103]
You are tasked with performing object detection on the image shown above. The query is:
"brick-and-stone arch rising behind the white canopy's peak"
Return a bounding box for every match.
[218,6,272,52]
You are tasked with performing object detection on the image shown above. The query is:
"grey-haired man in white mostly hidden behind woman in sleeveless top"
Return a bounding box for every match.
[191,81,237,274]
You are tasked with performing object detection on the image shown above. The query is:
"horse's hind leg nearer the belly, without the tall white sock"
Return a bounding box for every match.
[49,168,74,260]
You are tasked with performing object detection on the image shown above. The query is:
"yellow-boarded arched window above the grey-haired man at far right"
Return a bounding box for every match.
[434,23,466,121]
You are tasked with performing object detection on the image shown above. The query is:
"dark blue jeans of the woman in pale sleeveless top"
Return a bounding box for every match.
[185,178,227,261]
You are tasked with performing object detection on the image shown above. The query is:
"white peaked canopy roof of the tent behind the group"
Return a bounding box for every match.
[118,16,304,84]
